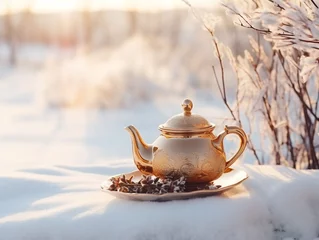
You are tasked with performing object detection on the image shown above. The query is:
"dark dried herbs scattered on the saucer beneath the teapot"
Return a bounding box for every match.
[108,175,221,194]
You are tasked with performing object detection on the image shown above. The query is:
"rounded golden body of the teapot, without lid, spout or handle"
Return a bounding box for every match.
[152,134,226,183]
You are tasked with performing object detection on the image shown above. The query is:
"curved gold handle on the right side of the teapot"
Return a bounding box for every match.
[213,125,247,169]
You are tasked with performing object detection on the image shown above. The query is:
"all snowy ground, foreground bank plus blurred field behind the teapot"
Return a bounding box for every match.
[0,56,319,240]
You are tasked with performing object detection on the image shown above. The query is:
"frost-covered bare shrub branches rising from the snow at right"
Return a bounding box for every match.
[196,0,319,169]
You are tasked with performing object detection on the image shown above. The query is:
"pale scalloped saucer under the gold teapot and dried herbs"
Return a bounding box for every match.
[101,168,248,201]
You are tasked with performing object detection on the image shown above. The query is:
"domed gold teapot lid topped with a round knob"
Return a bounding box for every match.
[159,99,214,133]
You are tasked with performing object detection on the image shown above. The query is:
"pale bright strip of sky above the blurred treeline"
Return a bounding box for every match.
[0,0,218,14]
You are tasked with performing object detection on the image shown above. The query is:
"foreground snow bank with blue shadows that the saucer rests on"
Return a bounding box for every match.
[0,161,319,240]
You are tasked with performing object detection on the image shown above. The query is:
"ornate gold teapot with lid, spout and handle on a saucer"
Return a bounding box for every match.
[125,99,247,183]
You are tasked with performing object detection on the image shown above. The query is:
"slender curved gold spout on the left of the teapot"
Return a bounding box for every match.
[125,125,153,174]
